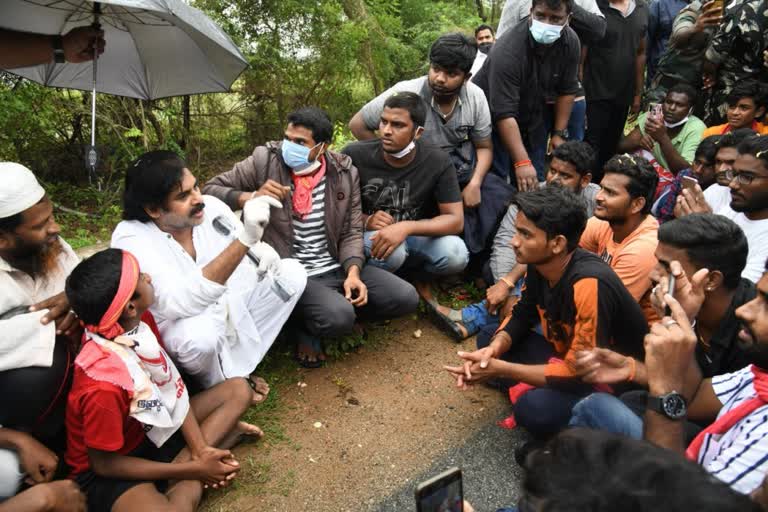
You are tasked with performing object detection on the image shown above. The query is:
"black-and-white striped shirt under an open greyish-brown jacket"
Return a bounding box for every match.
[293,176,341,276]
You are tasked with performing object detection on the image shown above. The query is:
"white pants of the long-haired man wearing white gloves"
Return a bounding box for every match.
[158,259,307,388]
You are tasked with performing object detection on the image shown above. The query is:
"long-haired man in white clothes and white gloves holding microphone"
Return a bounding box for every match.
[112,151,307,399]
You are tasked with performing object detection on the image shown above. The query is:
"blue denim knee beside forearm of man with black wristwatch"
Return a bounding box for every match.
[568,393,643,439]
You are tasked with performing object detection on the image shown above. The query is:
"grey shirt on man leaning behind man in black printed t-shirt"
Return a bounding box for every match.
[360,75,491,182]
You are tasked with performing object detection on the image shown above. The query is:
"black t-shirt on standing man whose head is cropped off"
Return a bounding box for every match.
[584,0,648,105]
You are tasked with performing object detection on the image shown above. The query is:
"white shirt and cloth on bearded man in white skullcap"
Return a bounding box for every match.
[0,238,79,371]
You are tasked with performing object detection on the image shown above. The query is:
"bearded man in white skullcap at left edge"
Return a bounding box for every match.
[0,162,79,498]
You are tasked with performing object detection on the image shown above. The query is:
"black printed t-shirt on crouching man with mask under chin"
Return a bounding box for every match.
[341,139,461,222]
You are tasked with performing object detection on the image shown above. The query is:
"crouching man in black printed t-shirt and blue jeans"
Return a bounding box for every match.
[342,92,469,286]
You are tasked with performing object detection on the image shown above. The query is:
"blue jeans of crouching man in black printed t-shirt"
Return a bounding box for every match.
[364,231,469,275]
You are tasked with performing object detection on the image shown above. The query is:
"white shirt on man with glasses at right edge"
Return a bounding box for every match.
[704,184,768,283]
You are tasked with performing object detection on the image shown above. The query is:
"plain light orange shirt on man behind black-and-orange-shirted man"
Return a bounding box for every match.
[579,215,659,325]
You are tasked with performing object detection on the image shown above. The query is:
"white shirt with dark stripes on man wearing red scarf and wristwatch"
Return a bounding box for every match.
[698,366,768,494]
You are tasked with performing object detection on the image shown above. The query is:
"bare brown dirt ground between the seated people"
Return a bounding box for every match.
[203,317,506,512]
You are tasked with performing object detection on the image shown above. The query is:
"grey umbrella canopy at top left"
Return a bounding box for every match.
[0,0,247,100]
